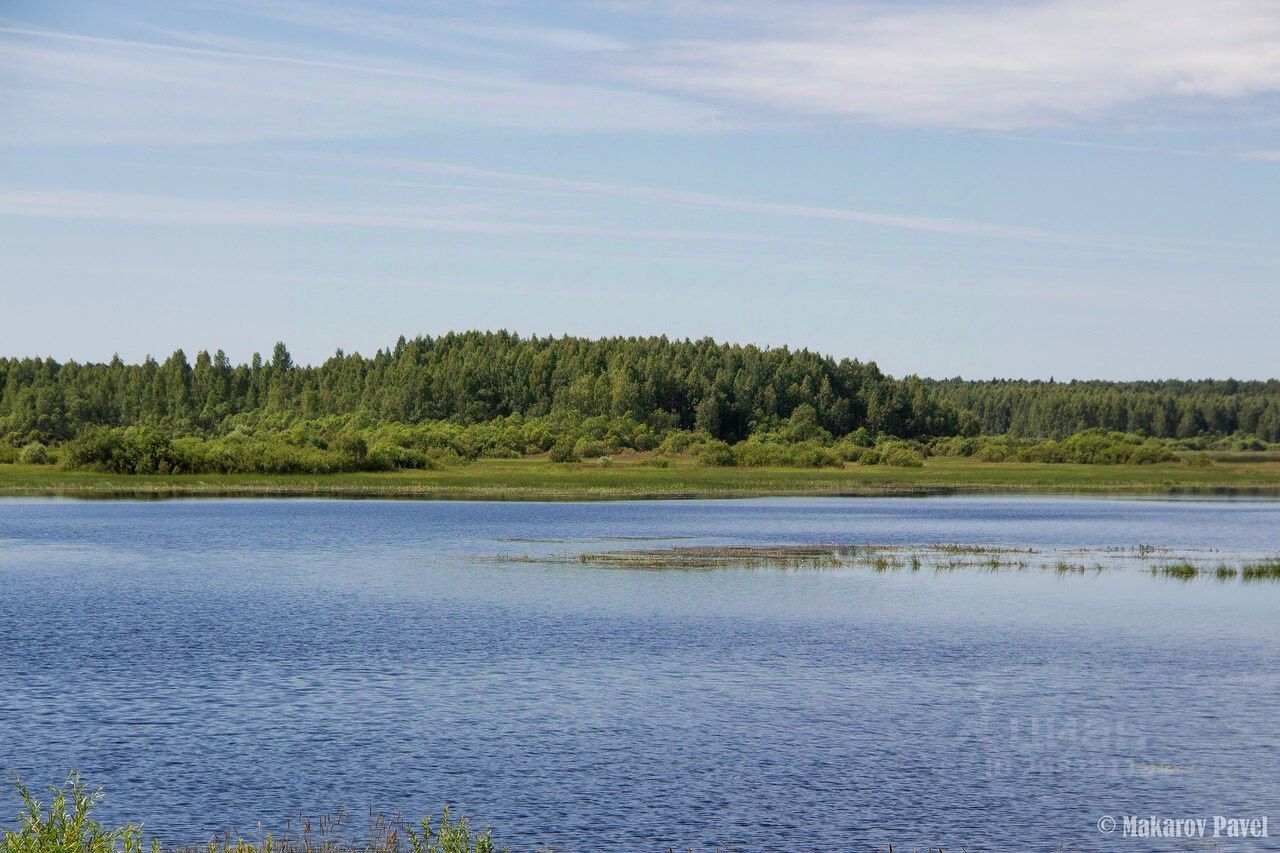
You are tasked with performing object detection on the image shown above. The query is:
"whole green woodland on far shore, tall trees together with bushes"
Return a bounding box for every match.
[0,332,1280,470]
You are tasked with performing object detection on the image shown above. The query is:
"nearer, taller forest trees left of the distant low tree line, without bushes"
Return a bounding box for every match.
[0,332,966,443]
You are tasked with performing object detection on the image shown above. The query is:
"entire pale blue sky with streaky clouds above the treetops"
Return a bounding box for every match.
[0,0,1280,378]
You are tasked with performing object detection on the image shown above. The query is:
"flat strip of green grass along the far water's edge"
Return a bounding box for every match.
[0,455,1280,501]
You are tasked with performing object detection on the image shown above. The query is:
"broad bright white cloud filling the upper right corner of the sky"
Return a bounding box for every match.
[608,0,1280,129]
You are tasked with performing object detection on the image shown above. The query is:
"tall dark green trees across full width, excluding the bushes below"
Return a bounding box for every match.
[0,332,1280,447]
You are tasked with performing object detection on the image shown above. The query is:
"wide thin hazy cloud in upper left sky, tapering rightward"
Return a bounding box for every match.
[0,19,722,145]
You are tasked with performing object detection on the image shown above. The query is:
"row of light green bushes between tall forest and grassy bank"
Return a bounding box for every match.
[15,406,1218,474]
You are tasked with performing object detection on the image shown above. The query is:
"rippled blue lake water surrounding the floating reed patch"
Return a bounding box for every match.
[0,497,1280,853]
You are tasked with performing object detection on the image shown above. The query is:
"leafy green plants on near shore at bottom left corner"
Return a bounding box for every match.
[0,774,507,853]
